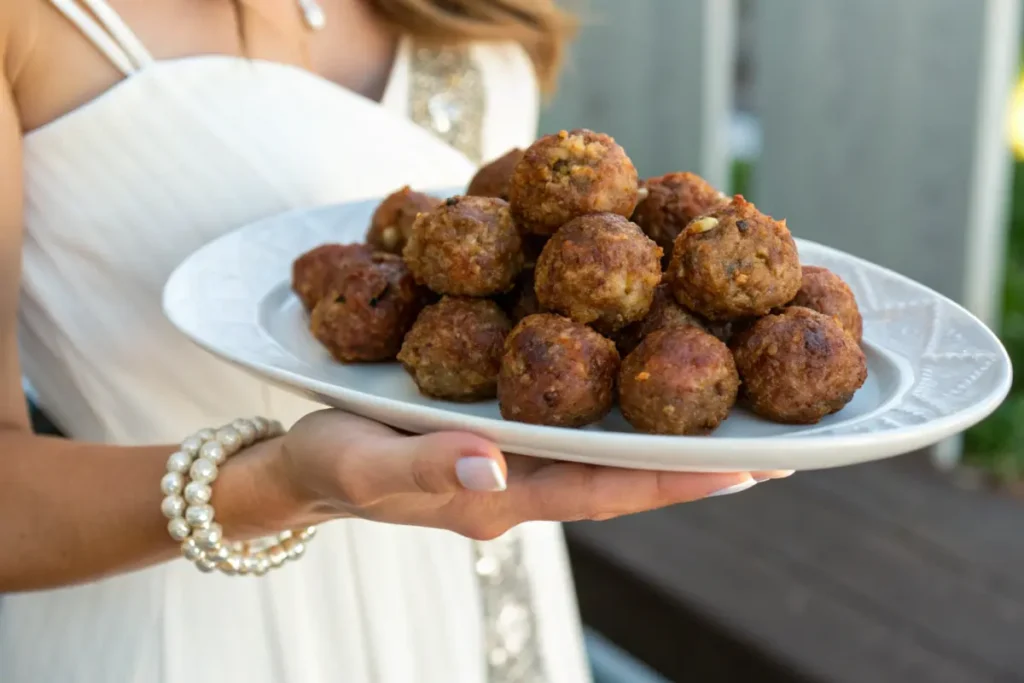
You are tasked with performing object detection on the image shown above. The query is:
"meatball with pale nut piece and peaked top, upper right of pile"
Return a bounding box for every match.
[667,195,801,321]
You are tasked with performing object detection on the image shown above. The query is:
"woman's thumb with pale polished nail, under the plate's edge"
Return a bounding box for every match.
[353,432,508,498]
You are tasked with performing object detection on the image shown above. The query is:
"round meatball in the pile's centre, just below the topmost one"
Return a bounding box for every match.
[535,213,662,333]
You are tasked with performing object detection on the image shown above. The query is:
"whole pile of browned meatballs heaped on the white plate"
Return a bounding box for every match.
[292,130,867,435]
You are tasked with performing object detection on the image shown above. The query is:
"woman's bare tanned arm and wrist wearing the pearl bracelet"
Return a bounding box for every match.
[0,50,311,593]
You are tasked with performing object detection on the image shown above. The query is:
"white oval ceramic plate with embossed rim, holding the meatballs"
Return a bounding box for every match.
[164,192,1012,471]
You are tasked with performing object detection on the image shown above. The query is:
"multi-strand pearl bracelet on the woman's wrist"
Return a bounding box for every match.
[160,418,316,577]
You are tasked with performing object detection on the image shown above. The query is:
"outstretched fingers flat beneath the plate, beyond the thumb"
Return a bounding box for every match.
[508,463,757,521]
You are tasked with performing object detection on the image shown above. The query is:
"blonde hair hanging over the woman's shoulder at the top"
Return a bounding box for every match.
[370,0,577,92]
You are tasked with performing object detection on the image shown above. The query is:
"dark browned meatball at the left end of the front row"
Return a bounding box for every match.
[310,253,426,362]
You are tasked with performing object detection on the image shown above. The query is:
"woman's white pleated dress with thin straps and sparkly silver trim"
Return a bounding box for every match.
[0,0,590,683]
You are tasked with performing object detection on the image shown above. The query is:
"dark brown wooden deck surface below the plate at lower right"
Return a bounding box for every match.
[567,456,1024,683]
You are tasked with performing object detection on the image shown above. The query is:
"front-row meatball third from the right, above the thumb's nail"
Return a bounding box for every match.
[498,313,618,427]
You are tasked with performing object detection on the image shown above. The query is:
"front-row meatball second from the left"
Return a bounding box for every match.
[398,296,512,401]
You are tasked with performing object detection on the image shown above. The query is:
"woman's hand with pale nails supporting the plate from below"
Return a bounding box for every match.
[275,411,790,540]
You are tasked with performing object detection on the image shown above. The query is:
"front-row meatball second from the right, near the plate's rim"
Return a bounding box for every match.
[618,326,739,434]
